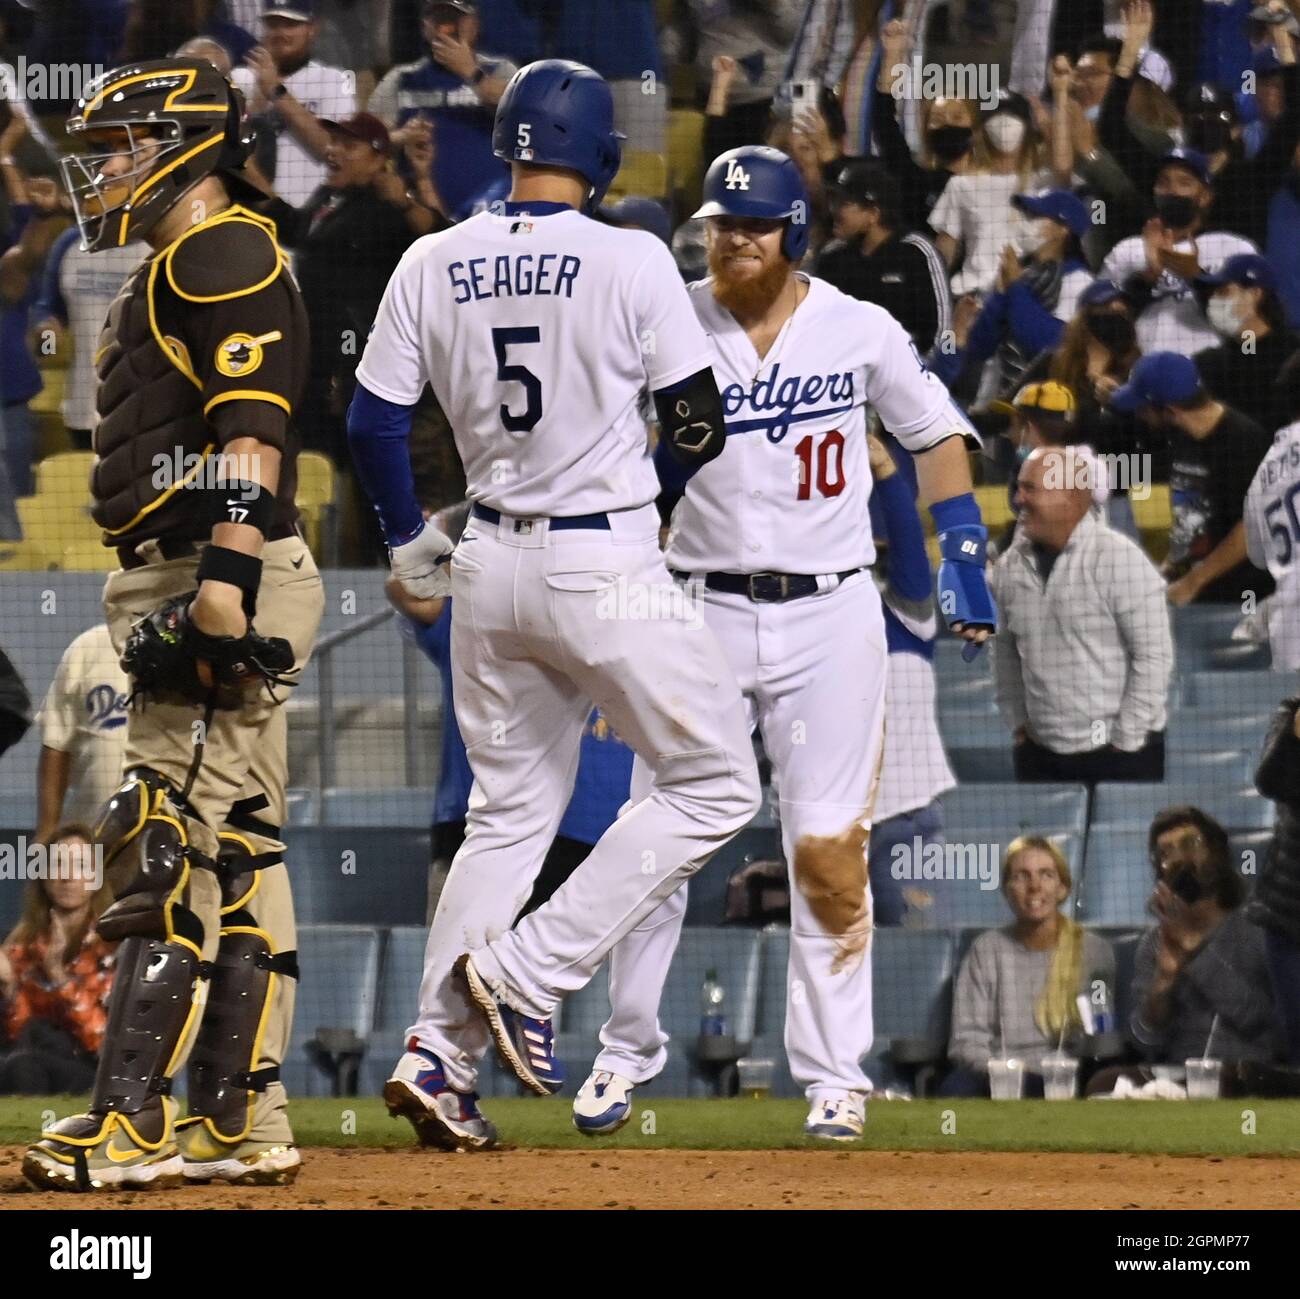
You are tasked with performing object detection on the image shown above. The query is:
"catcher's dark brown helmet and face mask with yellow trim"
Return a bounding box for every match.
[61,59,250,252]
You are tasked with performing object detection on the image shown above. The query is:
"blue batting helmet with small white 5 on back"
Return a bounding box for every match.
[491,59,627,207]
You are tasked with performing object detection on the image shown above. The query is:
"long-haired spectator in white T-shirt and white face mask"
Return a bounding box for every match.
[930,92,1049,295]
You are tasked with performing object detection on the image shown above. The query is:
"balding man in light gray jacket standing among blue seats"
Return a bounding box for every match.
[989,446,1174,784]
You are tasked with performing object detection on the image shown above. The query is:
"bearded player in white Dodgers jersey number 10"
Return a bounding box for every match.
[573,146,996,1140]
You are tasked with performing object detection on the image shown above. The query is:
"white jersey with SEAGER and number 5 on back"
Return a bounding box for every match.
[356,209,707,518]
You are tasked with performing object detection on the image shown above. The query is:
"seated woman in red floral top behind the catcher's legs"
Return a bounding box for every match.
[0,823,113,1096]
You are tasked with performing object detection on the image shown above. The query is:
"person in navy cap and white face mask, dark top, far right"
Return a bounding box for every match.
[1195,252,1297,432]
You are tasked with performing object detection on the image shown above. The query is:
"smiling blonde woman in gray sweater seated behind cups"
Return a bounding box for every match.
[939,835,1115,1096]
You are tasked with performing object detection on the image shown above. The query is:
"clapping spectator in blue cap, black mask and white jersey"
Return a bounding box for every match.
[1101,148,1258,356]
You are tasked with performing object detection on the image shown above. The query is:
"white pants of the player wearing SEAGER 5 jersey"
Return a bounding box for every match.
[407,506,761,1091]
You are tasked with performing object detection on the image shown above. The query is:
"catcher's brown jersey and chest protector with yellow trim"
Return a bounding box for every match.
[91,205,308,547]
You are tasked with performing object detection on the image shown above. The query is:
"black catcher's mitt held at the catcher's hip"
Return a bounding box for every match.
[122,590,295,709]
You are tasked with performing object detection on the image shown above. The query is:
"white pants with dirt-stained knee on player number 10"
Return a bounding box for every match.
[595,573,888,1103]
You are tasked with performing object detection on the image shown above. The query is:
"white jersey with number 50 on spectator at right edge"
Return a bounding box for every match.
[1244,420,1300,672]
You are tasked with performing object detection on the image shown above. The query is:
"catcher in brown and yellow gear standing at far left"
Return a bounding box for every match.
[22,59,324,1191]
